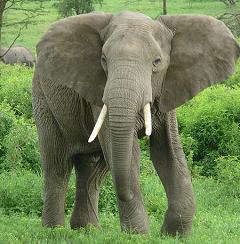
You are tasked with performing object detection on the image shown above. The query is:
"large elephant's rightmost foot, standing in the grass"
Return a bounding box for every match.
[161,210,193,236]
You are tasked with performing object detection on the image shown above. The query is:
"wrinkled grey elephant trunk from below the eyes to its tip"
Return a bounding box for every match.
[107,64,152,201]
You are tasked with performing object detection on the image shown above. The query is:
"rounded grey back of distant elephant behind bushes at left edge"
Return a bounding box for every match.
[0,46,35,68]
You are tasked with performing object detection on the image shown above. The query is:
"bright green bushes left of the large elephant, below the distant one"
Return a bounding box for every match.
[0,64,40,173]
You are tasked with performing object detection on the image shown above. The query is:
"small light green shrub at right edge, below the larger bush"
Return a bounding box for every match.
[216,156,240,197]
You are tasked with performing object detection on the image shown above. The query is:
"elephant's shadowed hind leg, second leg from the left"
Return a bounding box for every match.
[70,152,108,229]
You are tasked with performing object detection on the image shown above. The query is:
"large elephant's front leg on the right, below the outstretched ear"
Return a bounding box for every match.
[150,111,195,235]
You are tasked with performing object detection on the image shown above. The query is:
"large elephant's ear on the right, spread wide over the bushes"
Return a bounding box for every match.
[159,15,240,112]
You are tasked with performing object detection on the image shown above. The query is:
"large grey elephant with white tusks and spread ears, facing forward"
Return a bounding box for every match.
[32,11,240,236]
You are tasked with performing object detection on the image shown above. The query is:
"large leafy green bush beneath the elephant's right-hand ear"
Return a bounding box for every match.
[177,85,240,176]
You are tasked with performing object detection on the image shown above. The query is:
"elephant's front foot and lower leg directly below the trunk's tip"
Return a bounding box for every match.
[119,199,149,234]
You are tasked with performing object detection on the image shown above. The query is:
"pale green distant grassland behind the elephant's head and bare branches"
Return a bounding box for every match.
[2,0,231,52]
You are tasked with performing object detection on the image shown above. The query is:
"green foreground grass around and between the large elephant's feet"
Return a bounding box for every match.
[0,143,240,244]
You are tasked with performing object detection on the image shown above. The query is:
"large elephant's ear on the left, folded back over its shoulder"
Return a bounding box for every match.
[36,13,112,106]
